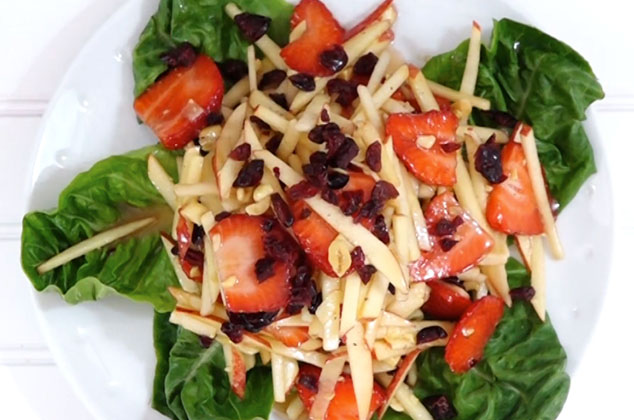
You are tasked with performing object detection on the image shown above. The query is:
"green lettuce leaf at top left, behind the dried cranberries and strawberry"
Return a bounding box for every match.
[132,0,293,96]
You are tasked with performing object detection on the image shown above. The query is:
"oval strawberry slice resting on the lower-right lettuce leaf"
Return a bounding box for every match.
[445,296,504,373]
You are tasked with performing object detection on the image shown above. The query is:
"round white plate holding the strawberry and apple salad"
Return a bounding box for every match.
[25,0,613,420]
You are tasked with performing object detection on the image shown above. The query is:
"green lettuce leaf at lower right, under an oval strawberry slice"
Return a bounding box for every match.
[415,260,570,420]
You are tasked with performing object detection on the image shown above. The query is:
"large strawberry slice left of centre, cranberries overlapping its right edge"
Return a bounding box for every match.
[211,214,292,312]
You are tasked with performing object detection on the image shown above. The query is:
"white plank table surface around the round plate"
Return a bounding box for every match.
[0,0,634,420]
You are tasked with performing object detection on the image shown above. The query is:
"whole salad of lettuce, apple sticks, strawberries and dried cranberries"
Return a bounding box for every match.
[22,0,603,420]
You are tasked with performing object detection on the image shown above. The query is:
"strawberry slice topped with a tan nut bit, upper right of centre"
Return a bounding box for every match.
[386,111,458,186]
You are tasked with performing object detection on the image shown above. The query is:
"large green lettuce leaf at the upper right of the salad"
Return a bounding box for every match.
[423,19,604,207]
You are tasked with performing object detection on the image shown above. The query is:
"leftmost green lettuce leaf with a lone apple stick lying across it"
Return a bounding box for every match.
[21,146,178,312]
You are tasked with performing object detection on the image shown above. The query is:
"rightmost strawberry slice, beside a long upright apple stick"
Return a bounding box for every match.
[486,142,544,235]
